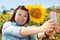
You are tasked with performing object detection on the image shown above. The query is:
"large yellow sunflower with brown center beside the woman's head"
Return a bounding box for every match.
[25,5,45,23]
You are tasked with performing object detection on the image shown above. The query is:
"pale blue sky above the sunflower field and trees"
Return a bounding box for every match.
[0,0,60,9]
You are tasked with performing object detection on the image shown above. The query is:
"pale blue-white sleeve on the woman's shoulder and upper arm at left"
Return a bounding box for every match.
[2,22,21,37]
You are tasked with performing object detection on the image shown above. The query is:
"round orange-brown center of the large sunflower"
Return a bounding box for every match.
[30,8,42,19]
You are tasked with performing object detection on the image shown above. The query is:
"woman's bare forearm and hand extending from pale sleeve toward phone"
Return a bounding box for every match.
[20,20,56,36]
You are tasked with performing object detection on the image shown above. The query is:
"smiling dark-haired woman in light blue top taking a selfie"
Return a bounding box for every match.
[2,6,55,40]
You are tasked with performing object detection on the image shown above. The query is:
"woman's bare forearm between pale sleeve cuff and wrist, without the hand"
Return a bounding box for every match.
[20,27,43,36]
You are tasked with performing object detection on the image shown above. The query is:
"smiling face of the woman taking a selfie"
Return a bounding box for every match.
[15,9,28,25]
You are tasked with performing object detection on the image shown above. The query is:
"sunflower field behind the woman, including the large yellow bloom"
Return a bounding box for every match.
[0,4,60,40]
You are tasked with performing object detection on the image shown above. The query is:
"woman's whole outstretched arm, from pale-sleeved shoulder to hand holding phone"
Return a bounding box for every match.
[2,20,55,36]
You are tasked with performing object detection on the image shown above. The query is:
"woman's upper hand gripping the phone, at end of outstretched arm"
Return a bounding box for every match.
[41,19,57,32]
